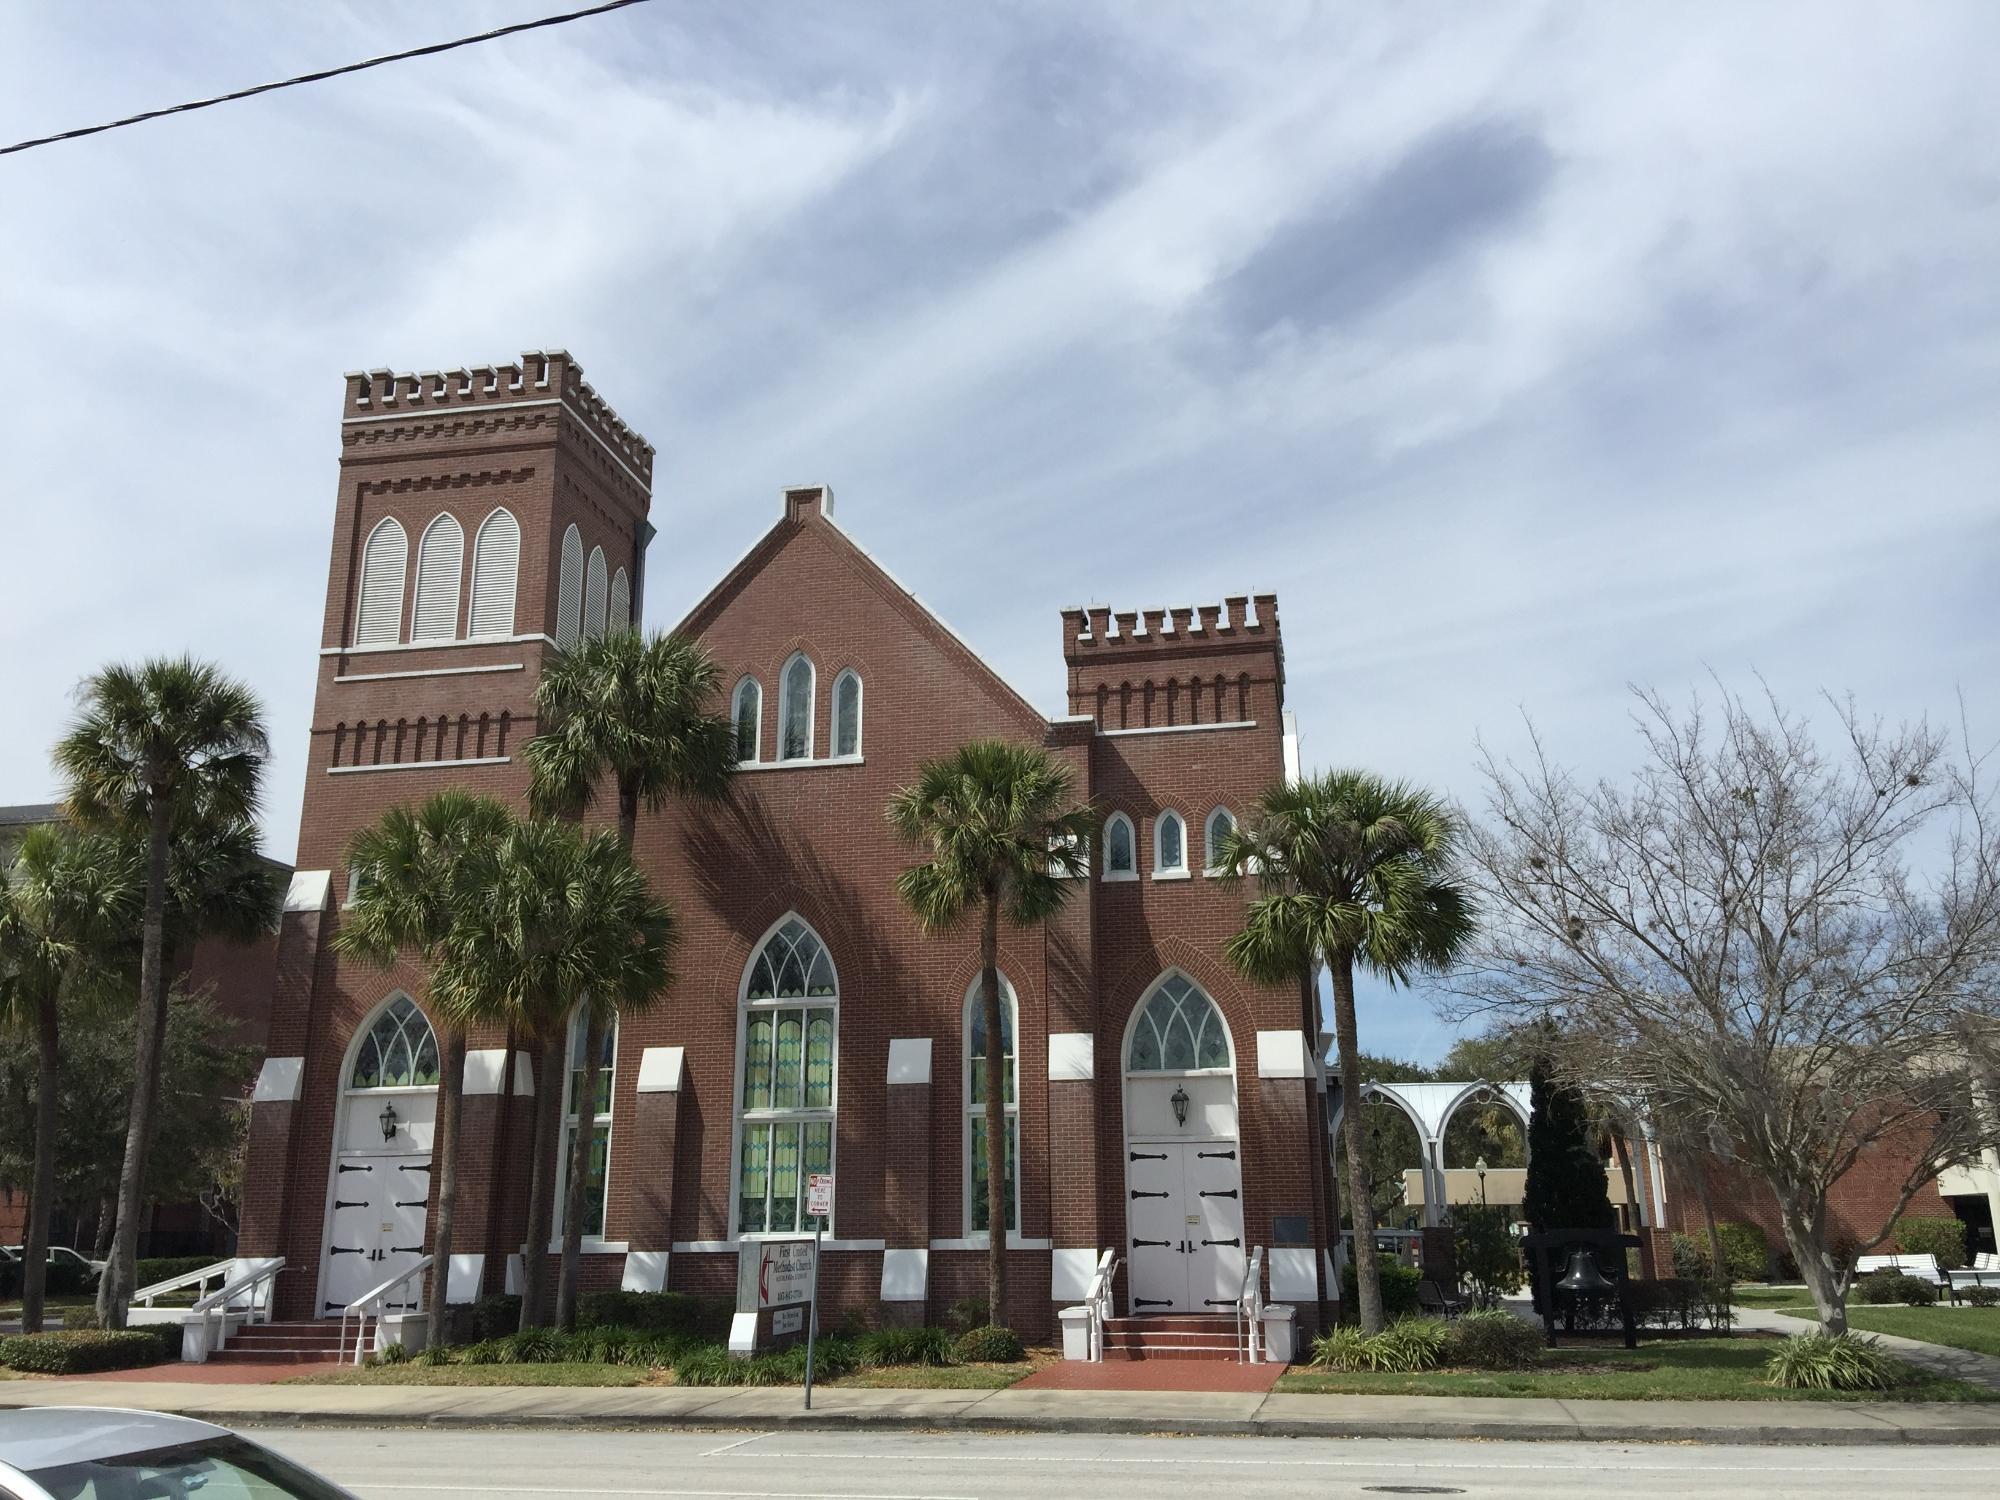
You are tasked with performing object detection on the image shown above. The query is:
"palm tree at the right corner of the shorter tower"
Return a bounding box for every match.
[1220,770,1474,1334]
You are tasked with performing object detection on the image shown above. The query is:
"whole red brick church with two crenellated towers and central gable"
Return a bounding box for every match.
[240,352,1332,1334]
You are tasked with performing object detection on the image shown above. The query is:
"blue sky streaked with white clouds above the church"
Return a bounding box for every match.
[0,0,2000,1058]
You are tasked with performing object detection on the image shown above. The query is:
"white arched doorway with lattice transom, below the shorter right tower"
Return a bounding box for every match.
[1124,970,1246,1316]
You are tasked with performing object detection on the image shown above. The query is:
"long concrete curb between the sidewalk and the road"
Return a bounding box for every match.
[19,1396,2000,1448]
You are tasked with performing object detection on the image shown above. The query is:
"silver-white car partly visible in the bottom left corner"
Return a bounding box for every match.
[0,1406,354,1500]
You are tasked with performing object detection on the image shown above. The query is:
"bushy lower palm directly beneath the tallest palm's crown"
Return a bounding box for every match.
[432,818,678,1328]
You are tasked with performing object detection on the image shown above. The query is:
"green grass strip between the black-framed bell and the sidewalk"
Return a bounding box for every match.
[1278,1338,2000,1402]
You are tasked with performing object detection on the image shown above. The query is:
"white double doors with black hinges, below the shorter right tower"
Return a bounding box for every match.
[1126,1140,1246,1316]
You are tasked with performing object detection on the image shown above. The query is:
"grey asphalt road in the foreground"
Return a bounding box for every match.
[252,1428,2000,1500]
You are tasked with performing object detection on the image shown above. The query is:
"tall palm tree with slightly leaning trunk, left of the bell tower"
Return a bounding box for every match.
[56,656,270,1328]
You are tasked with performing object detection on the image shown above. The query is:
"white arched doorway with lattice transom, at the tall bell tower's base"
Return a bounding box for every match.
[320,992,438,1318]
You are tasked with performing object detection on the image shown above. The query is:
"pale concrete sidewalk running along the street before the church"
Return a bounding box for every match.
[0,1378,2000,1446]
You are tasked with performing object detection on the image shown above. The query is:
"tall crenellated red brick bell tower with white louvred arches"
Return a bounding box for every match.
[240,350,654,1318]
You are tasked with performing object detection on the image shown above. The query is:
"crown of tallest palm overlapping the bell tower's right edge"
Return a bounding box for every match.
[522,630,736,850]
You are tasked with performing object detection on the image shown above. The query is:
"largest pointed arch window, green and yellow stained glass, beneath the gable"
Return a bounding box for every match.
[736,916,840,1234]
